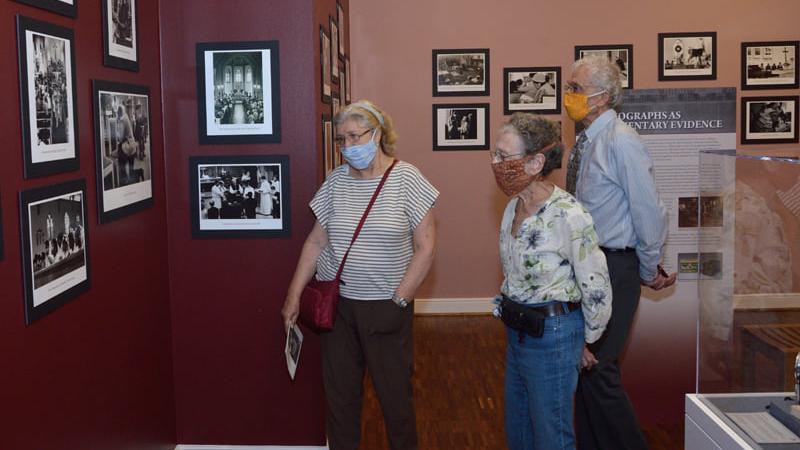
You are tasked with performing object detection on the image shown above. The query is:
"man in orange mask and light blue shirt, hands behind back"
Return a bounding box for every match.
[564,56,675,450]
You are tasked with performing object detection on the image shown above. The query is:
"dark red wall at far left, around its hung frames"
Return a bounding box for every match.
[0,0,175,450]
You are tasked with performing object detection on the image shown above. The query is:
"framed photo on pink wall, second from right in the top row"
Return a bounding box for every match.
[658,31,717,81]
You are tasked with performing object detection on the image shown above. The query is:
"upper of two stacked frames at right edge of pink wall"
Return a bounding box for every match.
[742,41,800,89]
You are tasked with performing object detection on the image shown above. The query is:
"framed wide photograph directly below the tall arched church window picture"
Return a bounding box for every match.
[189,155,290,239]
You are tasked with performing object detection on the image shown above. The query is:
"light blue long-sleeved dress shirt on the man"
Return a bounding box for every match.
[575,110,667,281]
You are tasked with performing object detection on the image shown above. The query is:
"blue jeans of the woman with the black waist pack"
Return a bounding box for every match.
[505,309,584,450]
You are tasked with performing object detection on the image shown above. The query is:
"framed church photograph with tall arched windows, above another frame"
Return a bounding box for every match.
[197,41,281,144]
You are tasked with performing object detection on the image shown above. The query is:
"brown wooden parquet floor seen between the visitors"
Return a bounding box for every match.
[361,315,683,450]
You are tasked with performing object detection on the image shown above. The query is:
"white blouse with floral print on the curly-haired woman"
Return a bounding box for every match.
[500,186,612,343]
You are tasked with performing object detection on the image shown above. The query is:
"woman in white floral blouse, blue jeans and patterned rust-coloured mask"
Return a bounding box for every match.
[491,113,611,450]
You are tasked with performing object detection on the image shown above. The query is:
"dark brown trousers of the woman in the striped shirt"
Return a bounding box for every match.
[322,297,417,450]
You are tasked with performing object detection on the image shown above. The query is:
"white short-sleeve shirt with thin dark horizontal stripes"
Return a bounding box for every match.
[310,161,439,300]
